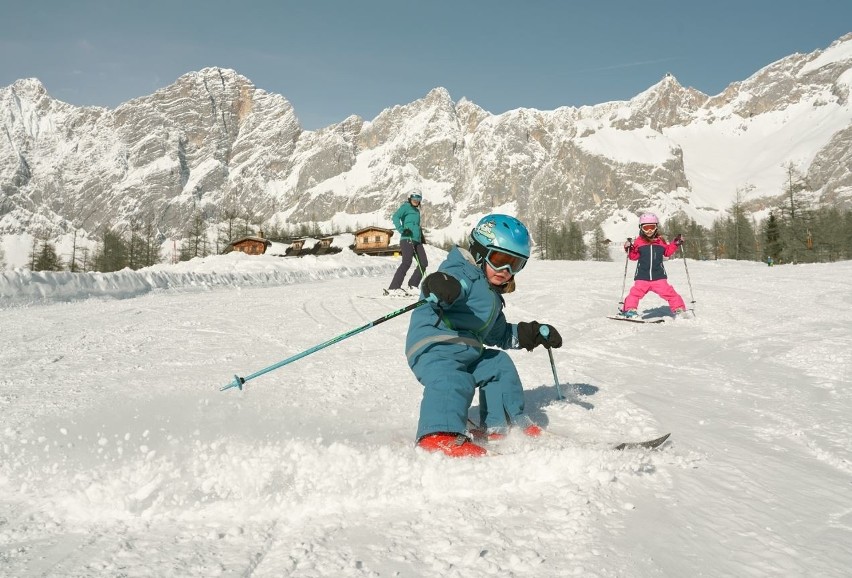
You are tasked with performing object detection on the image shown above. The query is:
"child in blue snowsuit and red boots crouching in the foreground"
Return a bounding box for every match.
[406,215,562,457]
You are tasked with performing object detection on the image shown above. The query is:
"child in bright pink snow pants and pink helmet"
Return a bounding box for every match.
[619,213,686,317]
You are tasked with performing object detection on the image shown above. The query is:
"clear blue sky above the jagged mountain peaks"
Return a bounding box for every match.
[0,0,852,129]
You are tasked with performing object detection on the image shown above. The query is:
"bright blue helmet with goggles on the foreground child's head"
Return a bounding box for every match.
[470,215,530,275]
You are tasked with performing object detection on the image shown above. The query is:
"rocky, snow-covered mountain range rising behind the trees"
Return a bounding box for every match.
[0,34,852,256]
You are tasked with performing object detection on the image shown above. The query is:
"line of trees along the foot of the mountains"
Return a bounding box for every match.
[16,186,852,272]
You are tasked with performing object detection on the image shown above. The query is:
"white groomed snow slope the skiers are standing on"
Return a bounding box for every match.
[0,244,852,578]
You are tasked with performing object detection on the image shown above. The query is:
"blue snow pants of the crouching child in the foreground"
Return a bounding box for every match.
[411,342,529,439]
